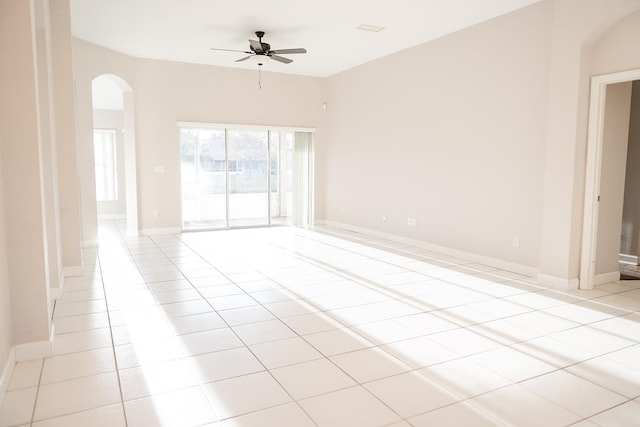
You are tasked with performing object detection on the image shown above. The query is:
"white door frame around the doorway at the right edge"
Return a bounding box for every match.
[580,69,640,289]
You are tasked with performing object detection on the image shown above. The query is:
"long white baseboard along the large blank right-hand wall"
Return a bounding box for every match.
[315,220,538,277]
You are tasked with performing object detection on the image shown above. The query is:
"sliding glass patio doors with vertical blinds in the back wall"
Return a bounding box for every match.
[179,123,313,231]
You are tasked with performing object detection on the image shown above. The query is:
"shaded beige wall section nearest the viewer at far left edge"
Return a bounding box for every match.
[0,0,56,360]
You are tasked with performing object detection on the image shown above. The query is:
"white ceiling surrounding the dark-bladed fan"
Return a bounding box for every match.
[71,0,540,77]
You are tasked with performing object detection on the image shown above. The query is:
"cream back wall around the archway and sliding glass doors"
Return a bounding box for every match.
[74,40,324,234]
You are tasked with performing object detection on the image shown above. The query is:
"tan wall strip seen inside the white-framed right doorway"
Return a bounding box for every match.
[595,82,631,274]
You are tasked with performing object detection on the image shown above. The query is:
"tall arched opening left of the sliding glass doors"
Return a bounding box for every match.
[91,74,138,236]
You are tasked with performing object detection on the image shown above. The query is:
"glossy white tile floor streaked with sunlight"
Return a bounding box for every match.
[0,222,640,427]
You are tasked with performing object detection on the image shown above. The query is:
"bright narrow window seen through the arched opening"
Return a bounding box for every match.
[93,129,118,202]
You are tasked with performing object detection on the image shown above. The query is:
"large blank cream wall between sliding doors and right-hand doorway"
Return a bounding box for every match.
[318,3,551,267]
